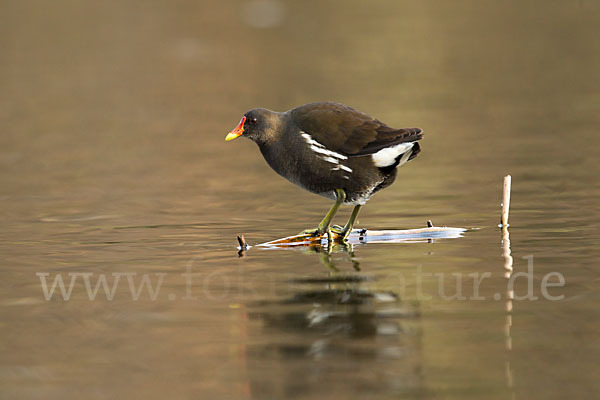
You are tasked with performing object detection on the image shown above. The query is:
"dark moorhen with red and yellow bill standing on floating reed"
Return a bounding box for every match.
[225,102,423,241]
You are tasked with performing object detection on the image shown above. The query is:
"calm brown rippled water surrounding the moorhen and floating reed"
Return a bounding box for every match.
[0,0,600,399]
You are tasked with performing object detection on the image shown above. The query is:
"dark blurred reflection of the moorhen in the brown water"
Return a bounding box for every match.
[247,245,421,398]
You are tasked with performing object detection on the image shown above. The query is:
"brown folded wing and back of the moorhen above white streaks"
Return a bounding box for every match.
[292,102,423,157]
